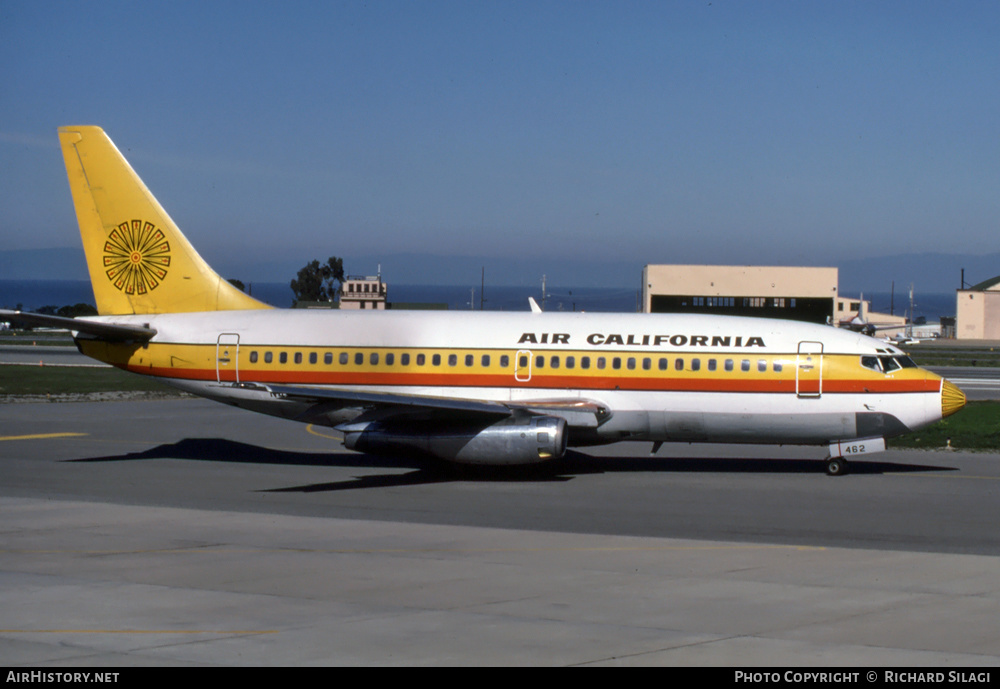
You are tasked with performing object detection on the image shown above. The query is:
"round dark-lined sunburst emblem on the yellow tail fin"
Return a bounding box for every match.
[104,220,170,295]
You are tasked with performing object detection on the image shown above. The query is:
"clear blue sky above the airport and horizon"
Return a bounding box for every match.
[0,0,1000,282]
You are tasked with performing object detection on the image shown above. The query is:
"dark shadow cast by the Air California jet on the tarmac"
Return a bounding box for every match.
[66,438,957,493]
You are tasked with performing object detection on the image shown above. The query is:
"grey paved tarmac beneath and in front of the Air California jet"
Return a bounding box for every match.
[0,399,1000,667]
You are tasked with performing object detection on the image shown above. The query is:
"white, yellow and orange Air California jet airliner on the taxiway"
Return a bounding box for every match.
[0,126,965,475]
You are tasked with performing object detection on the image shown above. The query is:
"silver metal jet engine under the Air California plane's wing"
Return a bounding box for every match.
[341,416,566,465]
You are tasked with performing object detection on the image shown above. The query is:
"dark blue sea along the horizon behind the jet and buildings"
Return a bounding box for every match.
[0,280,955,322]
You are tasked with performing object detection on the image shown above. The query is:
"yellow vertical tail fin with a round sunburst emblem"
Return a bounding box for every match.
[59,127,271,315]
